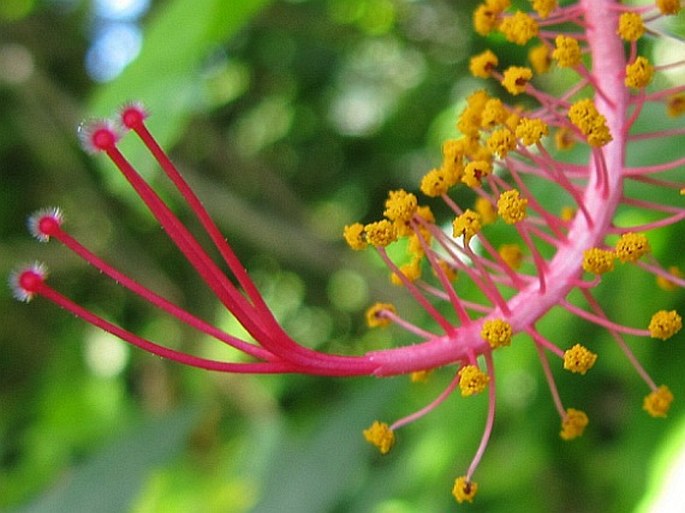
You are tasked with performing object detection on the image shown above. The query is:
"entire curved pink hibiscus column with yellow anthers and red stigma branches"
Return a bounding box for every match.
[12,0,685,502]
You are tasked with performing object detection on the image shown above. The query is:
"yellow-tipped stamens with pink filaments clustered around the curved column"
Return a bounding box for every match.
[344,0,685,502]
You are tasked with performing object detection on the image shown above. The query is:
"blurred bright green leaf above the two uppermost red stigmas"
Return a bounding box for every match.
[88,0,270,146]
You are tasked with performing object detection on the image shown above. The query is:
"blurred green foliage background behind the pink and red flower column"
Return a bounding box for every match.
[0,0,685,513]
